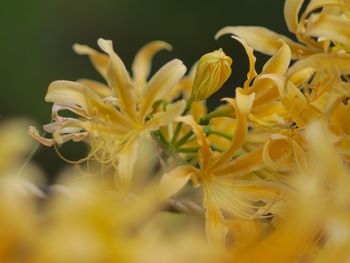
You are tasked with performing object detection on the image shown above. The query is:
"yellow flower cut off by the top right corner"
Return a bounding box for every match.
[216,0,350,59]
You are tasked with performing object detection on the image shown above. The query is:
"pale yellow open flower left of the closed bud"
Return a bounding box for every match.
[31,39,186,191]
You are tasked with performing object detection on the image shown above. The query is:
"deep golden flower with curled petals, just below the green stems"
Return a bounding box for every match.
[161,100,281,245]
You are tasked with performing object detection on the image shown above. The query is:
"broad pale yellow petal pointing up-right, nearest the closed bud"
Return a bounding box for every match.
[140,59,186,118]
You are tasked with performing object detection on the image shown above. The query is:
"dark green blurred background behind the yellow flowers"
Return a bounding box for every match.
[0,0,288,179]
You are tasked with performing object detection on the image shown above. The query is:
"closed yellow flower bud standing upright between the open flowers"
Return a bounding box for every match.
[191,49,232,101]
